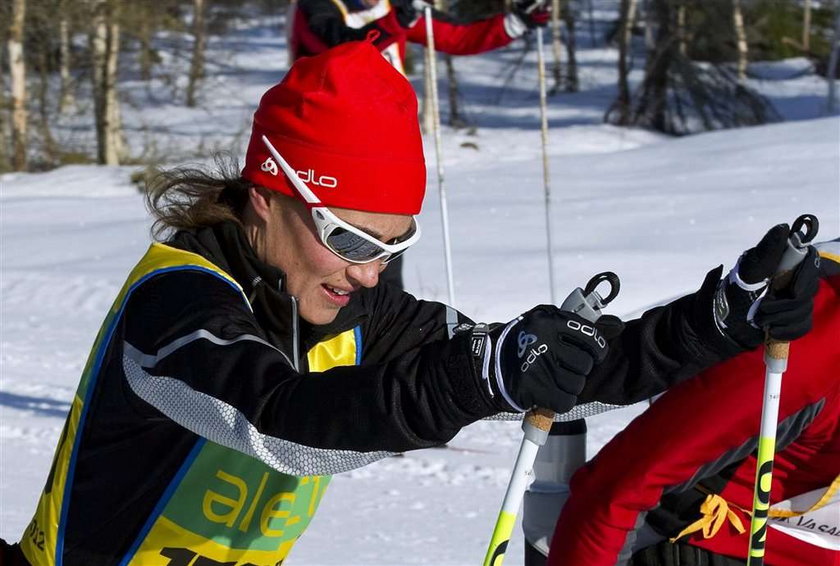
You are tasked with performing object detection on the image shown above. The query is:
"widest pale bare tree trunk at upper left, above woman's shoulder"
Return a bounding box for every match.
[91,0,125,165]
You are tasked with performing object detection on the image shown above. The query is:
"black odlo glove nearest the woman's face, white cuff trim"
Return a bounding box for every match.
[472,305,608,413]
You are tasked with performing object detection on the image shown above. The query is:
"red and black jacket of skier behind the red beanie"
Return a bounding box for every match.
[289,0,524,73]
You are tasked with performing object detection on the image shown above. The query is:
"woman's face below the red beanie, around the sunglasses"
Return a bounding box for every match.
[246,189,411,324]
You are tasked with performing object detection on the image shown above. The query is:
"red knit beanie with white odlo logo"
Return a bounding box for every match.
[242,42,426,214]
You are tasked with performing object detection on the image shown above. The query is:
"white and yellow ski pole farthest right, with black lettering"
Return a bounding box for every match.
[747,214,819,566]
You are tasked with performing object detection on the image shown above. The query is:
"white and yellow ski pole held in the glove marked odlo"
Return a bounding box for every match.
[484,271,619,566]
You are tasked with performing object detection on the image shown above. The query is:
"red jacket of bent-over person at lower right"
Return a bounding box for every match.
[547,240,840,566]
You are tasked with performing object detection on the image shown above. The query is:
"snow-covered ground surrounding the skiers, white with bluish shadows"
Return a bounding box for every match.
[0,10,840,566]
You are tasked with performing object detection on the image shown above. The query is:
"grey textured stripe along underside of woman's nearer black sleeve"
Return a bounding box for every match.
[123,352,392,476]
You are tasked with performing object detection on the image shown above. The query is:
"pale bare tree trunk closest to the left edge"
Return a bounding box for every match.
[6,0,27,171]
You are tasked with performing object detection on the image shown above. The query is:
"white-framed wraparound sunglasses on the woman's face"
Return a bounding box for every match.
[262,136,420,263]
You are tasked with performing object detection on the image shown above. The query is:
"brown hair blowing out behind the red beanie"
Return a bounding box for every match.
[146,155,254,240]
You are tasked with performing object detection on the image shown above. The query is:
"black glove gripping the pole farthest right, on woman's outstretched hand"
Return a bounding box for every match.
[714,224,819,349]
